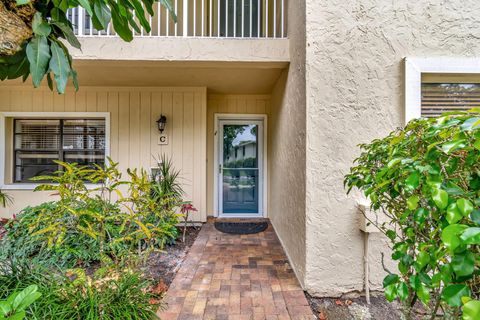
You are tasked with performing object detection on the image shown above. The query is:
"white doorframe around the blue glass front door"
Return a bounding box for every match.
[213,113,268,218]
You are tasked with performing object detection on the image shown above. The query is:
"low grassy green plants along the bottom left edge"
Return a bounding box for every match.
[0,258,162,320]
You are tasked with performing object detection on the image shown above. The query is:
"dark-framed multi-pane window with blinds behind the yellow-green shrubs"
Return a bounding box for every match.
[13,119,105,182]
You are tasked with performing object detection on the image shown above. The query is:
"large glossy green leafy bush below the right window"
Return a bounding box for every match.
[345,112,480,319]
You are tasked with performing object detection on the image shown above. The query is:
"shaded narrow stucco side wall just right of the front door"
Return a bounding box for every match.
[269,0,306,285]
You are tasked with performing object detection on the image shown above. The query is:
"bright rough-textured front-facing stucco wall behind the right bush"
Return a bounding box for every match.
[305,0,480,296]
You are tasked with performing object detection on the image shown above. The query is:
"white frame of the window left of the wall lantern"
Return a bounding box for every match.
[0,112,110,190]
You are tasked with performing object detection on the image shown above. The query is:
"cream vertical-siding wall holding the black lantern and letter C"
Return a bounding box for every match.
[0,84,207,221]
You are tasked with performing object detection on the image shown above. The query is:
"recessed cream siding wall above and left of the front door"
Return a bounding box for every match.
[207,94,271,215]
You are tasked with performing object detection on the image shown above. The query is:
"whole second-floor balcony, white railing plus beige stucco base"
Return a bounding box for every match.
[69,0,290,64]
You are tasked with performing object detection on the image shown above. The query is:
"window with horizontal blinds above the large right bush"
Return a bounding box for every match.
[422,83,480,117]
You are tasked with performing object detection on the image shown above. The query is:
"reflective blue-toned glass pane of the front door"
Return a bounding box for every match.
[222,125,259,213]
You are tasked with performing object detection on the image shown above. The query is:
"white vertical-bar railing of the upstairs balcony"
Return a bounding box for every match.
[68,0,287,38]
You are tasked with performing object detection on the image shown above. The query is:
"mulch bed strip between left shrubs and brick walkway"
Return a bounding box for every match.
[146,227,201,291]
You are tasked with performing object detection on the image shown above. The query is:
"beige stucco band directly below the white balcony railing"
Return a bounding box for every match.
[70,37,289,62]
